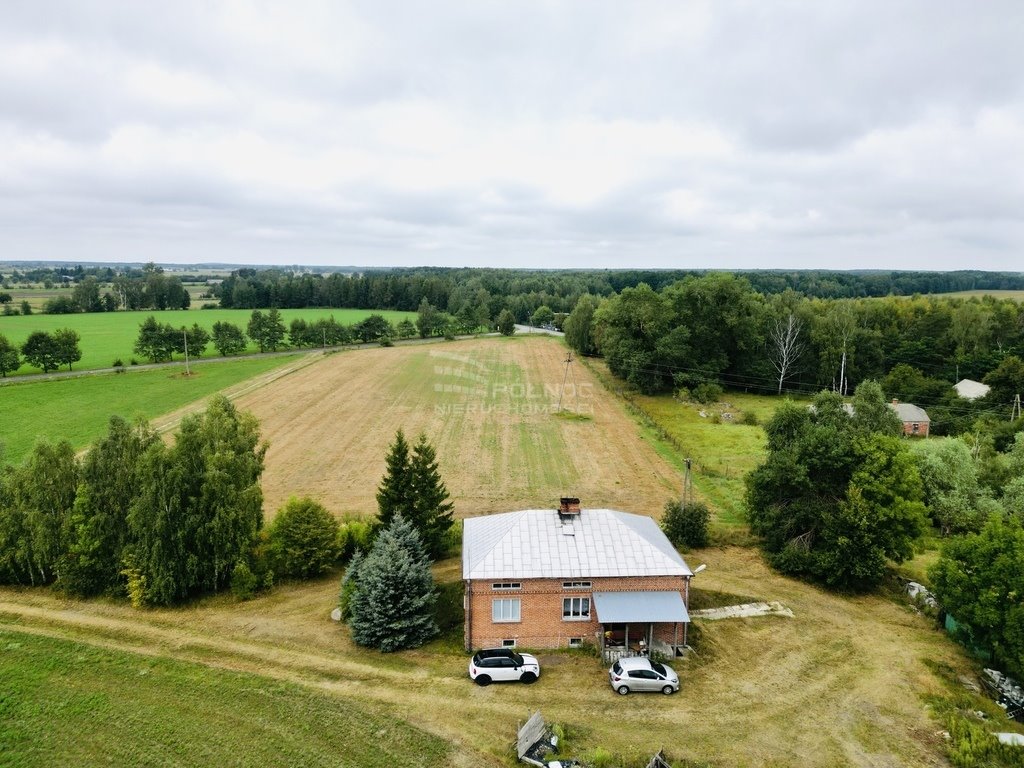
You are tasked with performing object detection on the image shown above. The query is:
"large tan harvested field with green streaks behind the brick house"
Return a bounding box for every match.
[238,337,679,517]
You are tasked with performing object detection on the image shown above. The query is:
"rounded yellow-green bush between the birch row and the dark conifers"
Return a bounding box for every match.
[267,499,338,579]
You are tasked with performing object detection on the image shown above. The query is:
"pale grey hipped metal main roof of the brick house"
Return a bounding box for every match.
[462,509,693,579]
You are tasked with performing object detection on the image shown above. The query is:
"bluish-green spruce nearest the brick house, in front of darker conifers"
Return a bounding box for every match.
[349,514,437,653]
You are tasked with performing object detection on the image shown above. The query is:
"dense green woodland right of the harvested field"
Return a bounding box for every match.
[564,273,1024,434]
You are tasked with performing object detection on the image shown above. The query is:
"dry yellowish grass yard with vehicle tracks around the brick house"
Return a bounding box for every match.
[0,548,971,767]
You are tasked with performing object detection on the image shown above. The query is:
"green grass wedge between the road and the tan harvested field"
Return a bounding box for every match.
[0,355,296,464]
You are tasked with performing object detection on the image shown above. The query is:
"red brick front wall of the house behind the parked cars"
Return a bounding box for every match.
[465,577,689,649]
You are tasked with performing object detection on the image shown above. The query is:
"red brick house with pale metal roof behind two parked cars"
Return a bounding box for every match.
[462,499,693,654]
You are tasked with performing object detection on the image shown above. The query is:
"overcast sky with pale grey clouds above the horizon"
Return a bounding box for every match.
[0,0,1024,271]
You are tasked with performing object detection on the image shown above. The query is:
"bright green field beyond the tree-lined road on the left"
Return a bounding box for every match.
[0,309,416,374]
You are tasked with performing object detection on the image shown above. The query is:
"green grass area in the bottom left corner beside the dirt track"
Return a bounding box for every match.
[0,631,450,768]
